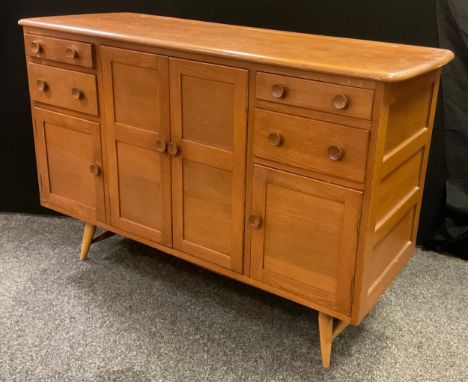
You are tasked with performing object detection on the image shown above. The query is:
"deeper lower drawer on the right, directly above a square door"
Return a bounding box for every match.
[253,109,369,183]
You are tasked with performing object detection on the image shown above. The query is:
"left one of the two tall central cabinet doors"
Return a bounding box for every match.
[101,47,172,245]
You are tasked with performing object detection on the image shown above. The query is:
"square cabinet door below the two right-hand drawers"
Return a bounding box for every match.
[249,166,361,314]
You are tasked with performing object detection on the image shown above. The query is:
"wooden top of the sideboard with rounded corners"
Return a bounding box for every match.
[19,13,454,81]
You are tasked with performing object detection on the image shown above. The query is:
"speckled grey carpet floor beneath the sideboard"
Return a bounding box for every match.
[0,214,468,382]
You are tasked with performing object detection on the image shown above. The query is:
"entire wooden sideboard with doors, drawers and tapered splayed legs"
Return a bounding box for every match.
[19,13,453,367]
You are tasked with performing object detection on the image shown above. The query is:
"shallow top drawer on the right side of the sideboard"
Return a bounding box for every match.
[256,72,374,120]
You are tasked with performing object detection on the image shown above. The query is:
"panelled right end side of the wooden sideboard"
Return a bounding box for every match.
[352,70,439,324]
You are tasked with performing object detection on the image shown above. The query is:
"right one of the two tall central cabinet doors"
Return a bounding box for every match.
[170,59,247,272]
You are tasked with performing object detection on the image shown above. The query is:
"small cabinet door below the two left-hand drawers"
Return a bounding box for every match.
[33,108,105,222]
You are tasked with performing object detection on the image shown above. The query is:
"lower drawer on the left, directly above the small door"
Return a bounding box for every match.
[28,62,98,116]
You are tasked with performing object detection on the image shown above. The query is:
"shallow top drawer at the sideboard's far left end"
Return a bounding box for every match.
[24,34,94,68]
